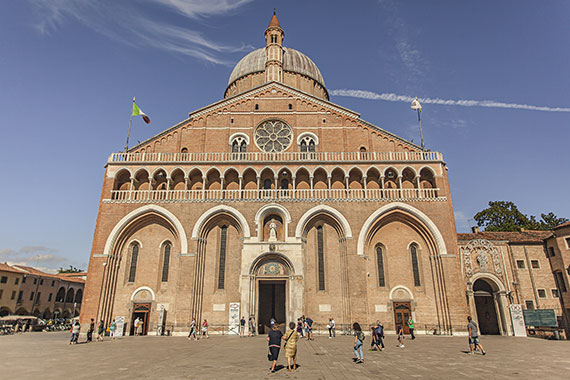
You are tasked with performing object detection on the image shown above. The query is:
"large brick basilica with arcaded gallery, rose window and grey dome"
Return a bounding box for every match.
[81,15,564,334]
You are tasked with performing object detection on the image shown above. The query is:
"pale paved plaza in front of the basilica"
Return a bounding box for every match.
[0,332,570,380]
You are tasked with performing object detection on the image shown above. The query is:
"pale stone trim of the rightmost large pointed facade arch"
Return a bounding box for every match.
[356,202,447,256]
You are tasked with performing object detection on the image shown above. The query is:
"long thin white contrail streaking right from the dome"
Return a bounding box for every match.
[329,89,570,112]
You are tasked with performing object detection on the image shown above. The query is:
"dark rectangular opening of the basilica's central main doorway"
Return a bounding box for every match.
[257,280,285,334]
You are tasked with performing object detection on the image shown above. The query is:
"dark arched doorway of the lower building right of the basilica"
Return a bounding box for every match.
[473,278,501,335]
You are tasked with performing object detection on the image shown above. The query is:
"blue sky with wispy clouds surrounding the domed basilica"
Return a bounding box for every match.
[0,0,570,269]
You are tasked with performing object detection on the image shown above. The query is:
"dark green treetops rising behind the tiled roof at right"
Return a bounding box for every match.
[474,201,568,231]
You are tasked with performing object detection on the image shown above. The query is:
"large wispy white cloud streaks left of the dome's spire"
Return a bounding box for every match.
[28,0,253,65]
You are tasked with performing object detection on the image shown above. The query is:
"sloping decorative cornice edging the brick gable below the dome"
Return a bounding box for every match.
[128,82,422,152]
